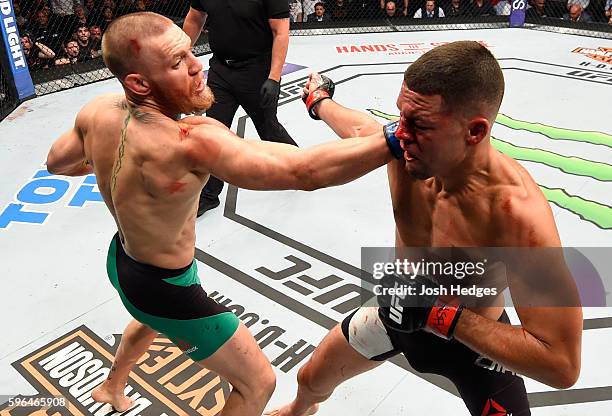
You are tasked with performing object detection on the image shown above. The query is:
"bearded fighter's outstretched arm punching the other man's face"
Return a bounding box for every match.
[185,121,392,190]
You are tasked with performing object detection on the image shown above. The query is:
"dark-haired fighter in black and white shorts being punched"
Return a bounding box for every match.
[268,42,582,416]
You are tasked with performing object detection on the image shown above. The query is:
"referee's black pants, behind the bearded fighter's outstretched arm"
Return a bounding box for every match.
[201,54,297,203]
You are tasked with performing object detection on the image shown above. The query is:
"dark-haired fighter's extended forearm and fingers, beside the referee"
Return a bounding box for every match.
[303,72,382,139]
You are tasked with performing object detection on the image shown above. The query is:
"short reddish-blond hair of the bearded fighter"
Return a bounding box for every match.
[102,12,174,81]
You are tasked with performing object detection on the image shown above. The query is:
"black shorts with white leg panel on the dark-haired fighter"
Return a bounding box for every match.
[341,308,531,416]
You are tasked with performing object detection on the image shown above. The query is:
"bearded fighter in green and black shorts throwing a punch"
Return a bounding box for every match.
[47,12,391,416]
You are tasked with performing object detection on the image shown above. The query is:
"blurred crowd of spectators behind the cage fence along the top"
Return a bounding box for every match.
[14,0,612,71]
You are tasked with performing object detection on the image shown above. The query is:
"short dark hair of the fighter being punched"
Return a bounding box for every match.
[404,41,504,114]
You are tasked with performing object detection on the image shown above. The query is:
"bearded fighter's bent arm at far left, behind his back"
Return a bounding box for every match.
[47,106,93,176]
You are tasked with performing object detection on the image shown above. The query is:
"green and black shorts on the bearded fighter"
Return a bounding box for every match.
[106,234,239,361]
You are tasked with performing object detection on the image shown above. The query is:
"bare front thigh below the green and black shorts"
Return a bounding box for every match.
[198,322,274,391]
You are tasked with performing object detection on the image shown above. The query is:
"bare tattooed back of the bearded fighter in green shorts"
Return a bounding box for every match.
[81,95,207,269]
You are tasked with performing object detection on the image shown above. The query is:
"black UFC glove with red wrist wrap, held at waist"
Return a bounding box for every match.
[377,275,463,339]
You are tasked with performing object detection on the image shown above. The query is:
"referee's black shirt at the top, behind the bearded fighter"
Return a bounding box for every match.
[191,0,289,60]
